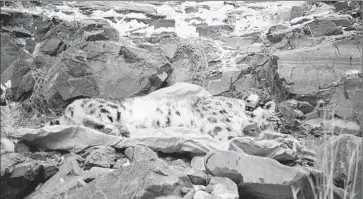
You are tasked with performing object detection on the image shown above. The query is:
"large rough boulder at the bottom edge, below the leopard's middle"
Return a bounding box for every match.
[69,160,192,199]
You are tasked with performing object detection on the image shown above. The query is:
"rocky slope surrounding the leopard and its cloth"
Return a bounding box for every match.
[0,1,363,199]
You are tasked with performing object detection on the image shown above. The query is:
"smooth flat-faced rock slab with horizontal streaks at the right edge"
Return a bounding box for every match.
[276,36,362,95]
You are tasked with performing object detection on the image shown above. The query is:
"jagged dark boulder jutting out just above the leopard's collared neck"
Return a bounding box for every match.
[212,53,285,101]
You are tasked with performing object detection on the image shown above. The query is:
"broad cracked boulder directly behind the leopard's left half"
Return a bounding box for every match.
[43,41,169,107]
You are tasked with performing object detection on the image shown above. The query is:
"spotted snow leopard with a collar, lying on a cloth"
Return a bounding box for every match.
[46,96,275,141]
